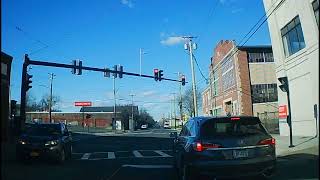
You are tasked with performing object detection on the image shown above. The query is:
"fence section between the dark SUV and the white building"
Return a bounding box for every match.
[257,112,279,134]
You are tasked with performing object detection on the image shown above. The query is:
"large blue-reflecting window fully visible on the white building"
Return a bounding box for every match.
[281,16,306,57]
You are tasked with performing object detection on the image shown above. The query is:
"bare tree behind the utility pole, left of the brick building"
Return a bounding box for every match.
[182,86,201,116]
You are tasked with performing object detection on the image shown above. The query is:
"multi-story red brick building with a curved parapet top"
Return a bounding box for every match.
[202,40,278,124]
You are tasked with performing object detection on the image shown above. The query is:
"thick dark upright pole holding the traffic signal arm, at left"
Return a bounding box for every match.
[16,54,29,133]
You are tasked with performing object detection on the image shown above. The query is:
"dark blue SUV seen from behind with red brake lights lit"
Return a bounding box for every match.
[174,116,276,179]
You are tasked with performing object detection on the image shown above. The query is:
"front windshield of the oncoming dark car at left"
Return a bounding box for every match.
[25,124,61,136]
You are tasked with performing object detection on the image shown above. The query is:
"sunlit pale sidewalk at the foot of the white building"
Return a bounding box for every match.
[272,134,319,157]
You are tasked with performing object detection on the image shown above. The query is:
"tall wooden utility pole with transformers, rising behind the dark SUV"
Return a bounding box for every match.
[182,36,198,116]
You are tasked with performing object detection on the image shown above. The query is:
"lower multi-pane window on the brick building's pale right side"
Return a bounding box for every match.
[251,84,278,103]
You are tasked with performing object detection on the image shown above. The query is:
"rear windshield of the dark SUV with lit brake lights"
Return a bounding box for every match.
[200,118,267,137]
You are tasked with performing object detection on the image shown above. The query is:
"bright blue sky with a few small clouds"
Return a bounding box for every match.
[1,0,270,120]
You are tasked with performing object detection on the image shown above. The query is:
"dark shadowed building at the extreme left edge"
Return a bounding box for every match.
[0,52,13,141]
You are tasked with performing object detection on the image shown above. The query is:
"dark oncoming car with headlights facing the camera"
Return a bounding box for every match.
[16,123,72,163]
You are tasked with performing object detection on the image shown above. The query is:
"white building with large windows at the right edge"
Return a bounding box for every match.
[263,0,319,136]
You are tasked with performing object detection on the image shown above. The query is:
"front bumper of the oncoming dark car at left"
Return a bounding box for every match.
[17,145,61,160]
